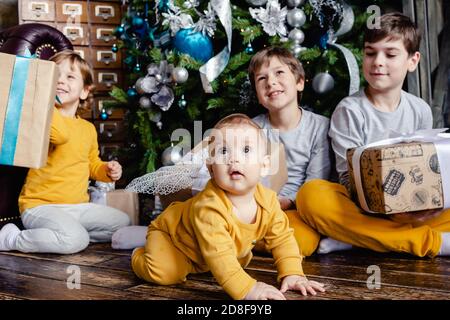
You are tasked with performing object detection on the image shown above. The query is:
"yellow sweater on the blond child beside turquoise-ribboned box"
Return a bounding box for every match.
[19,108,111,213]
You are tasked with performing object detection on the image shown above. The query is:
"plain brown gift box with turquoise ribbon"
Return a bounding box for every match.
[0,53,58,168]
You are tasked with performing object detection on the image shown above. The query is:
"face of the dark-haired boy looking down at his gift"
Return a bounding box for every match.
[363,38,420,93]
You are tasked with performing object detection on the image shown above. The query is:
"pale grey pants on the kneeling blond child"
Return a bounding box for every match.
[11,203,130,254]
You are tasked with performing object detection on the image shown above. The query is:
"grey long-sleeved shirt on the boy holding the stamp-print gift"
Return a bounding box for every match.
[329,89,433,188]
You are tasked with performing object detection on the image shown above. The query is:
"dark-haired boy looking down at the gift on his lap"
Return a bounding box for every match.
[298,13,450,257]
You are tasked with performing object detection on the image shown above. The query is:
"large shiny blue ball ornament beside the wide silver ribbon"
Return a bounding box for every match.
[174,28,214,62]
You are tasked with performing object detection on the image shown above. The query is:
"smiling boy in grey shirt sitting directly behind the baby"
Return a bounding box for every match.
[248,47,331,256]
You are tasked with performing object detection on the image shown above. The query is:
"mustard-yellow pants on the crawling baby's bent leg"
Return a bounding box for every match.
[131,230,198,285]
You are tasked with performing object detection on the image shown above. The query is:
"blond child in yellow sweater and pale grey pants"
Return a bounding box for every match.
[0,51,130,254]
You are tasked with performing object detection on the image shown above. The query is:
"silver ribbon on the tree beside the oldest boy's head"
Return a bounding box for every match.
[327,1,360,95]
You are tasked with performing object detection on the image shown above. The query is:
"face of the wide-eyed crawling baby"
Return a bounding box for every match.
[208,125,269,195]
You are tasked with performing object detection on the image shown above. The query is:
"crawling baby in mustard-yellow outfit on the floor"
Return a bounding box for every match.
[131,114,325,300]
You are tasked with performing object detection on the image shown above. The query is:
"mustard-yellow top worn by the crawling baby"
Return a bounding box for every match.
[149,180,303,299]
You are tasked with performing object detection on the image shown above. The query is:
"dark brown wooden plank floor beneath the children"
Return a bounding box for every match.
[0,244,450,300]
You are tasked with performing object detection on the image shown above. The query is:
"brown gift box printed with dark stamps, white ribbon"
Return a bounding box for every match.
[347,142,442,214]
